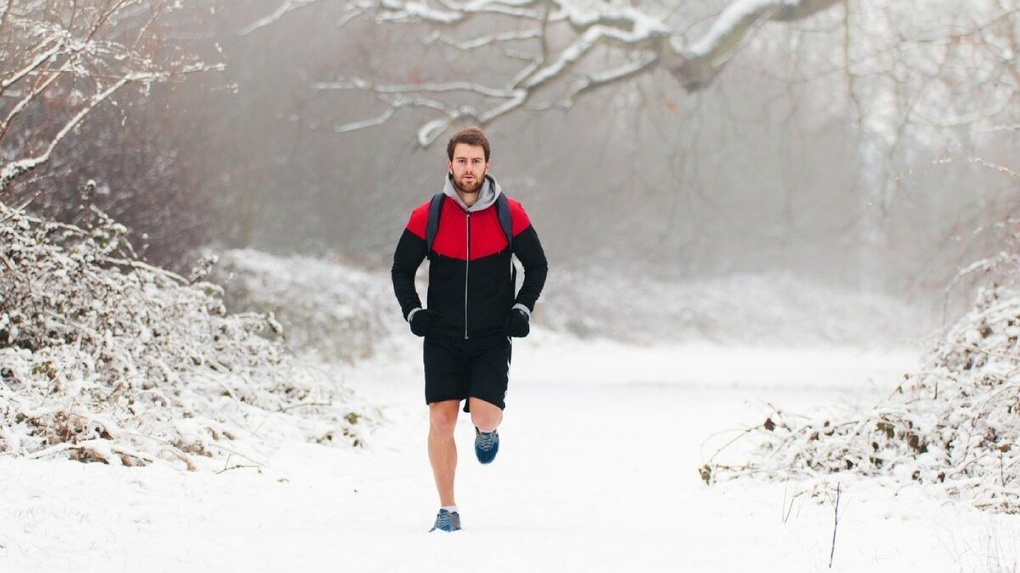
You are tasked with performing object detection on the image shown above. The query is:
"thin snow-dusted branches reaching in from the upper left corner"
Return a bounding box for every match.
[0,0,219,192]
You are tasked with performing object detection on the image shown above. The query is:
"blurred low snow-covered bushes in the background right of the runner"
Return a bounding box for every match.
[536,269,922,346]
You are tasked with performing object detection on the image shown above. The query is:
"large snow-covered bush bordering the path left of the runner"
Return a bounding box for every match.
[0,204,359,469]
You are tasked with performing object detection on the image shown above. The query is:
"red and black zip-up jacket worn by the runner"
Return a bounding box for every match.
[391,175,548,338]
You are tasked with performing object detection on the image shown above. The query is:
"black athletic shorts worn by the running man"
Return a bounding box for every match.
[423,336,510,412]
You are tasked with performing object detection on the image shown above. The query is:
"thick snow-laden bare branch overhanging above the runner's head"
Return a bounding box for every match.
[248,0,844,147]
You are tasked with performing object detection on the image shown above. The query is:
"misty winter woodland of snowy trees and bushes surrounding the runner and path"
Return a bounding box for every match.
[0,0,1020,570]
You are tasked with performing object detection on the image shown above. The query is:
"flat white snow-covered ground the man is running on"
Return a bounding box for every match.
[0,330,1020,573]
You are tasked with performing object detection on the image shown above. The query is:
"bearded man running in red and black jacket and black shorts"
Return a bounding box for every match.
[392,127,548,531]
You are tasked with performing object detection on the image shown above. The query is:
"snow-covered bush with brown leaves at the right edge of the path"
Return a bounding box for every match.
[701,285,1020,513]
